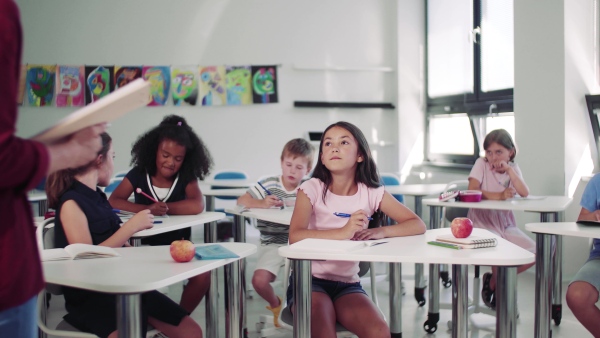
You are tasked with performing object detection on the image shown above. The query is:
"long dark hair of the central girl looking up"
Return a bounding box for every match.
[312,121,381,202]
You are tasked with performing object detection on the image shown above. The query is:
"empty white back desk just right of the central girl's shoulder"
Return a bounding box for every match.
[385,183,449,306]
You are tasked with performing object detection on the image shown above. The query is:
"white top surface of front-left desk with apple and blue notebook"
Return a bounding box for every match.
[42,243,256,294]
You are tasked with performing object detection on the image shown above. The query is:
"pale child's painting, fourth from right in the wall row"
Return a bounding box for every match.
[171,66,199,106]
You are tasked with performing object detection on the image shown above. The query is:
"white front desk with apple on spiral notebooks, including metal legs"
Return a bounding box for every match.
[279,229,535,338]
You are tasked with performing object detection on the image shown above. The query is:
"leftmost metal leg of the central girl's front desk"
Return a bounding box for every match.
[291,259,312,338]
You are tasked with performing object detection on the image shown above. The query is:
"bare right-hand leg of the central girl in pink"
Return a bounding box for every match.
[332,293,390,338]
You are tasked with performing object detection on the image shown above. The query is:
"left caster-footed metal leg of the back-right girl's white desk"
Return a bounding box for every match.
[423,206,442,333]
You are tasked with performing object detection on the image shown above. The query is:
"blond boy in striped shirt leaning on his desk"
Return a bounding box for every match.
[237,138,315,327]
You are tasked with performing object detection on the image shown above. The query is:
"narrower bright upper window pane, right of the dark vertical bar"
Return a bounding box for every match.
[481,0,515,92]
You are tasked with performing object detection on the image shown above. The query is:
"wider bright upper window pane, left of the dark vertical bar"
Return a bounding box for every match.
[427,0,473,98]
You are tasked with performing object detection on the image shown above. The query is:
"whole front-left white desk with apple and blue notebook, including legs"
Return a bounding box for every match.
[42,243,256,338]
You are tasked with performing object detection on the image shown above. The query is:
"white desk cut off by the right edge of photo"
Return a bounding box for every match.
[525,222,600,338]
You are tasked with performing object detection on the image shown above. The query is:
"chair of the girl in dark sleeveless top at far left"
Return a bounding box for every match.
[36,217,159,338]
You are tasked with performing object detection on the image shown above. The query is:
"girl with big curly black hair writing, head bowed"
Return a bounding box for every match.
[108,115,212,313]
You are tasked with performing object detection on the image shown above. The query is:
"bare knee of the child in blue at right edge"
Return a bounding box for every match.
[567,282,600,337]
